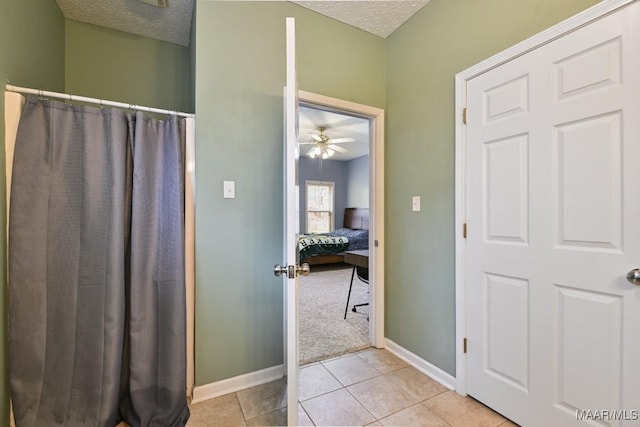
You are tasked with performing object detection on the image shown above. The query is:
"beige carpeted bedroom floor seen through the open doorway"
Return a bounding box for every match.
[299,264,369,365]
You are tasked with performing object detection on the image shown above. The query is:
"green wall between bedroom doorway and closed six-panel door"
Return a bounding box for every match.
[385,0,597,375]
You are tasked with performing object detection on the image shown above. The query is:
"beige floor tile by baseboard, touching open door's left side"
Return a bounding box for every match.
[236,379,287,420]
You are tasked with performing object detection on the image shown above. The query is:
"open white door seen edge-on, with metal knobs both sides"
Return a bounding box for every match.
[274,18,309,425]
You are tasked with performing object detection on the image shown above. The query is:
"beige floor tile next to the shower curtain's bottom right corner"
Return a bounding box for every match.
[187,393,245,427]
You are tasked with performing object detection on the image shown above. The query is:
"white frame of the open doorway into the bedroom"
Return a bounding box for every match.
[298,90,384,348]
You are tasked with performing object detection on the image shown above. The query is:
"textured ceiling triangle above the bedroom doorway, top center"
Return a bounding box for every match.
[291,0,429,38]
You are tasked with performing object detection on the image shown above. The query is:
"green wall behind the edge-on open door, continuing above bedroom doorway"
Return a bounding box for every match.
[196,0,385,385]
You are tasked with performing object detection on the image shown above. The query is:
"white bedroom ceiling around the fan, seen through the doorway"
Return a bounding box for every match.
[298,106,369,161]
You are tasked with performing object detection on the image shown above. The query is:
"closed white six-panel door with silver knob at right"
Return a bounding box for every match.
[465,2,640,426]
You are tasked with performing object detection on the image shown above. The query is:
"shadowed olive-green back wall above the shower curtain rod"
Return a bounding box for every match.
[65,19,194,112]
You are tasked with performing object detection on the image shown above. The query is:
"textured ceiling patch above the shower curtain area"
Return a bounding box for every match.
[56,0,193,46]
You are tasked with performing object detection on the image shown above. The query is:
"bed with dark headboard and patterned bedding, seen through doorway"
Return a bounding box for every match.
[298,208,369,265]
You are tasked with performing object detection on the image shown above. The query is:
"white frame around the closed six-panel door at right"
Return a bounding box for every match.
[455,0,640,395]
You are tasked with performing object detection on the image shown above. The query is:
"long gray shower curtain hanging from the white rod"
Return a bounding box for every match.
[9,98,188,427]
